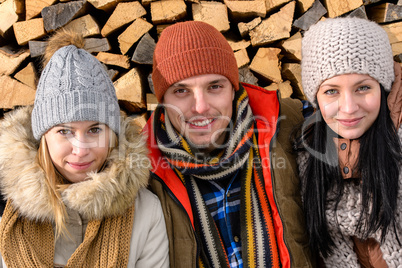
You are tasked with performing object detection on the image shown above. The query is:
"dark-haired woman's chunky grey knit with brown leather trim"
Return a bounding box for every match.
[297,52,402,268]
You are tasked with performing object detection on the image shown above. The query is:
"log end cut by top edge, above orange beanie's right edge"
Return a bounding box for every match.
[224,0,267,21]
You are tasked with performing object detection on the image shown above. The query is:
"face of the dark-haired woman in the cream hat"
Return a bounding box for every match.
[317,74,381,139]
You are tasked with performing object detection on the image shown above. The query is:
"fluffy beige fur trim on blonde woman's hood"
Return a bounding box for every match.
[0,106,151,221]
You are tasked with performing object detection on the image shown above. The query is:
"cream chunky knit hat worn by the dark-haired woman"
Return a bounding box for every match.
[301,18,394,106]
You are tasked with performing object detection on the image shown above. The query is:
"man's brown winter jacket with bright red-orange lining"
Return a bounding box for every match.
[145,84,313,268]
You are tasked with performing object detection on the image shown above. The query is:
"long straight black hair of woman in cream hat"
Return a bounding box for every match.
[295,86,402,258]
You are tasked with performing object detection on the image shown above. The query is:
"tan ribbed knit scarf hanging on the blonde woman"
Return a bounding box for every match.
[0,200,134,268]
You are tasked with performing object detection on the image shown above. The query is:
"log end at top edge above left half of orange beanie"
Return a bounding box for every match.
[151,0,187,24]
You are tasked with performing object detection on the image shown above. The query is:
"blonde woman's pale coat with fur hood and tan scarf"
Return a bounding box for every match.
[0,107,169,267]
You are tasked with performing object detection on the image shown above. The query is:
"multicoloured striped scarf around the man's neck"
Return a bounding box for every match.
[153,87,280,267]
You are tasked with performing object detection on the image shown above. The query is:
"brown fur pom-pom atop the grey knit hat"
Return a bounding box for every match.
[42,28,85,68]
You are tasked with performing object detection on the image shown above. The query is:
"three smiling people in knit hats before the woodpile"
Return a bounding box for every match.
[0,15,402,268]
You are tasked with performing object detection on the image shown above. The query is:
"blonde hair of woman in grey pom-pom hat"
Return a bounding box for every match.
[36,131,118,239]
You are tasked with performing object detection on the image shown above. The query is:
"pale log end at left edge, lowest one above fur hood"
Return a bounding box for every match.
[0,75,36,109]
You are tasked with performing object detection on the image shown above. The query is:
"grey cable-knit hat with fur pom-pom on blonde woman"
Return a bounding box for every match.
[32,32,120,140]
